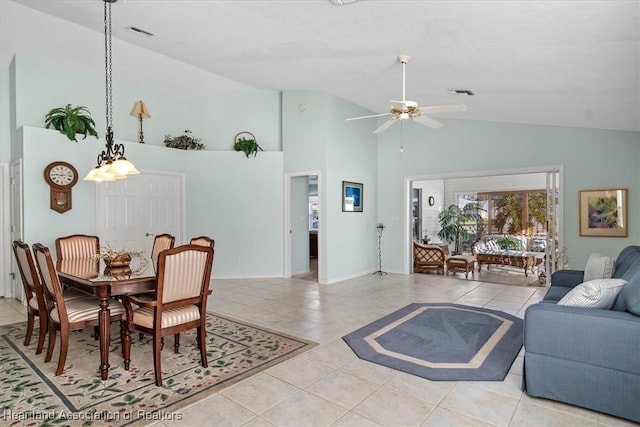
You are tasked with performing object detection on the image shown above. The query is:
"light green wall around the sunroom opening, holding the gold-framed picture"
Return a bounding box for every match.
[378,120,640,272]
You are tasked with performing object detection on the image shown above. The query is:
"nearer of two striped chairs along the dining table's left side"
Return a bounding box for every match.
[33,243,125,376]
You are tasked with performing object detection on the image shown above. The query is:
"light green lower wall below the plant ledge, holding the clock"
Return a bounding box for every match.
[19,126,284,277]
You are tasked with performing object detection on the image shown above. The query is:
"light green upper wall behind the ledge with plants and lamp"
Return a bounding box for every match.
[14,54,281,151]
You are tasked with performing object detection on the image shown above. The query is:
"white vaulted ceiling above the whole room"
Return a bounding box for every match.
[8,0,640,131]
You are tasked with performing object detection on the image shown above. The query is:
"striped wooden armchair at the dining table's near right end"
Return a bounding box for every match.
[123,245,214,386]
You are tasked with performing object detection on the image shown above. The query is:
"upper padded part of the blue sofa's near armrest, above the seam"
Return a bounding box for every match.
[524,303,640,375]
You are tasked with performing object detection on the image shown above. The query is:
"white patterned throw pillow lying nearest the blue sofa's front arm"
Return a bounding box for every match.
[558,279,627,310]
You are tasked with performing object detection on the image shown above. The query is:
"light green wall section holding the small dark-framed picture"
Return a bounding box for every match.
[282,91,377,283]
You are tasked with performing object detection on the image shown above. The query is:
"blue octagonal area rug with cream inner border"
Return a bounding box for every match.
[342,303,523,381]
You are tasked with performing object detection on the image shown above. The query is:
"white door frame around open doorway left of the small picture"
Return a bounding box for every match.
[283,170,326,283]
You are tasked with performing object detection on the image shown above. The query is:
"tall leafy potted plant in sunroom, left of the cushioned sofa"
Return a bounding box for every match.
[438,202,484,254]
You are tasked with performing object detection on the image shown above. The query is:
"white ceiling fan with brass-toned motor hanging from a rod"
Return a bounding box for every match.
[347,55,467,133]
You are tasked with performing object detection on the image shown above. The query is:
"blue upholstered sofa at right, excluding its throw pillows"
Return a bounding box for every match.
[522,246,640,422]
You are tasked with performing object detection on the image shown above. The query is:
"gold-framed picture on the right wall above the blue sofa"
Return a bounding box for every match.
[580,188,629,237]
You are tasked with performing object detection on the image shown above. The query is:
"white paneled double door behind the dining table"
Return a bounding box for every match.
[96,172,185,255]
